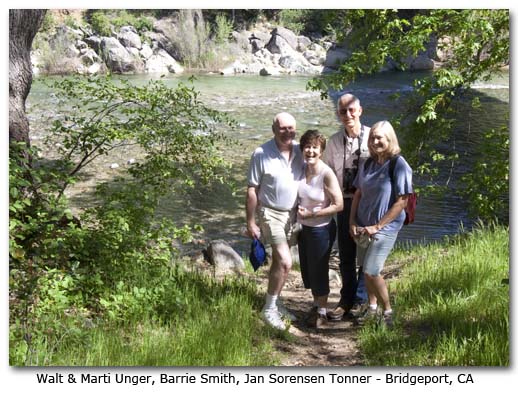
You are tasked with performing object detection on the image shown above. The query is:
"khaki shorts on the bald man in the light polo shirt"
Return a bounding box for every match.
[259,206,296,246]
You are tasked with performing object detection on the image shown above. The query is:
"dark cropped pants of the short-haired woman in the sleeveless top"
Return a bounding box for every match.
[298,219,336,296]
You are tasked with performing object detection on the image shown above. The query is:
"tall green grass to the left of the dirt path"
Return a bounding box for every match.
[16,272,278,366]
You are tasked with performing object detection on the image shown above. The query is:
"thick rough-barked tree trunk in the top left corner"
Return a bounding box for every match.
[9,9,47,145]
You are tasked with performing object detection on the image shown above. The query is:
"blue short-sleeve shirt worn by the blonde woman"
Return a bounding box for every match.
[354,156,414,233]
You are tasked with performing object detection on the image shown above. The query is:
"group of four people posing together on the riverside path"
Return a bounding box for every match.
[246,94,413,329]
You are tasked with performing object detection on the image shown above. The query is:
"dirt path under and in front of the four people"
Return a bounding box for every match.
[256,251,362,366]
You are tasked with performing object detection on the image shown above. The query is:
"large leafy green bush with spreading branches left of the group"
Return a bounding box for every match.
[9,78,238,364]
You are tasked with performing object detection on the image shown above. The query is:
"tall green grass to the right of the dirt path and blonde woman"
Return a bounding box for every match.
[360,226,510,366]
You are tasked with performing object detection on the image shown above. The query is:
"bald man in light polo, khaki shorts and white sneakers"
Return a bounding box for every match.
[246,112,304,329]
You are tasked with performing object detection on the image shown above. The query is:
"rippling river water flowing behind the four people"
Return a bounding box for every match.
[27,72,509,252]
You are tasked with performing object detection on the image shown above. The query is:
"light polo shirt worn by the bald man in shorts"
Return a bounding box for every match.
[248,139,304,211]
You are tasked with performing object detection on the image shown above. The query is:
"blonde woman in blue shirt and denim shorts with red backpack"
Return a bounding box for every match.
[350,121,413,326]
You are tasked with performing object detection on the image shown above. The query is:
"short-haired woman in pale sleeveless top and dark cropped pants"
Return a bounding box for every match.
[297,130,343,328]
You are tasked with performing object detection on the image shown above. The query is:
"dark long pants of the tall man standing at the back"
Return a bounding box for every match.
[336,198,368,306]
